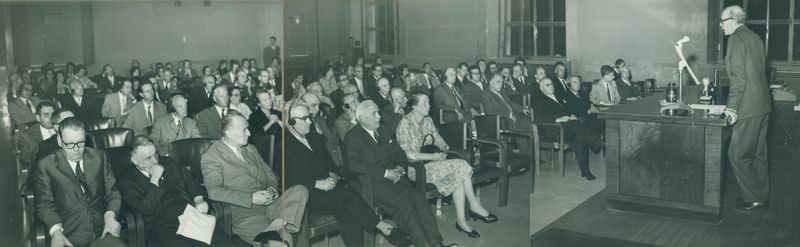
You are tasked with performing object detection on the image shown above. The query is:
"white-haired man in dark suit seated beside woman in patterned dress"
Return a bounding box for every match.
[344,100,454,246]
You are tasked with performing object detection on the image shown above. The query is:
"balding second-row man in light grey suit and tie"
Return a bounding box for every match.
[150,94,200,156]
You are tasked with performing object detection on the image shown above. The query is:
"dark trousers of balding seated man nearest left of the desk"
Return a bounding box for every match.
[564,121,603,173]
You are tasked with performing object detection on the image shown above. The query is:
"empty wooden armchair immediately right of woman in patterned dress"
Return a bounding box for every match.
[439,123,508,206]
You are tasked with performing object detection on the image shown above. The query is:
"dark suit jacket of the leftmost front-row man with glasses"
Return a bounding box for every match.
[31,147,122,240]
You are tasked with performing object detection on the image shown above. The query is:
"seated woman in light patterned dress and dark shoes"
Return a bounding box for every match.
[397,93,497,238]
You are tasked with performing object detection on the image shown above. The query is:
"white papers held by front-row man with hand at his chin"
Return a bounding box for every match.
[176,204,217,245]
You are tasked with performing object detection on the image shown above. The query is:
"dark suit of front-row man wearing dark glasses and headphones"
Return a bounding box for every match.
[283,132,380,246]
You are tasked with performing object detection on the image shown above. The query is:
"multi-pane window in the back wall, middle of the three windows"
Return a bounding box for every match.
[503,0,567,57]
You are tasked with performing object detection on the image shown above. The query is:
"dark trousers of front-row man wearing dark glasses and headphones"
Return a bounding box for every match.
[308,187,380,246]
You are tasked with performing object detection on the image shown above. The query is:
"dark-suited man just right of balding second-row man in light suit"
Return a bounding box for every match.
[195,84,231,139]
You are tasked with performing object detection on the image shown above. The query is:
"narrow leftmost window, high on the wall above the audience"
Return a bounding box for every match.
[364,0,400,55]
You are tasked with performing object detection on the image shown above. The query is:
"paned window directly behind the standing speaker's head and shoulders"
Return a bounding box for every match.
[717,0,800,62]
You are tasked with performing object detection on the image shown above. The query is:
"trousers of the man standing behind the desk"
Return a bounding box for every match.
[728,114,769,202]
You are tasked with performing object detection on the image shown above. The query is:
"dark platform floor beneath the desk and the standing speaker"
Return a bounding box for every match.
[532,146,800,247]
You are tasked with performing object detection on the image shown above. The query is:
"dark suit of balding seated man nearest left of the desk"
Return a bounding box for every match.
[533,91,603,172]
